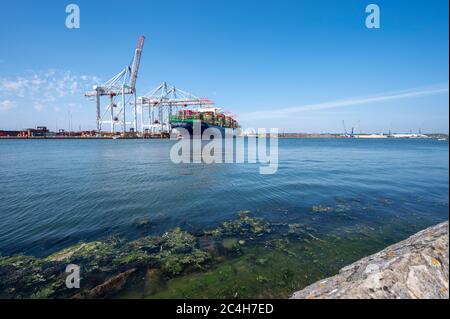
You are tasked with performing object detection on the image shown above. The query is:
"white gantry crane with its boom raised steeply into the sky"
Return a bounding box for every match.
[85,36,145,135]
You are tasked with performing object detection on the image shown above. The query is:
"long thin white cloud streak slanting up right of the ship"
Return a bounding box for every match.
[241,83,449,119]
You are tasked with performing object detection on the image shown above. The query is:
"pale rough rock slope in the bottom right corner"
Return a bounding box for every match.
[292,221,449,299]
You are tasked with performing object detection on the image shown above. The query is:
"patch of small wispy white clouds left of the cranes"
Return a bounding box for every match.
[0,70,99,111]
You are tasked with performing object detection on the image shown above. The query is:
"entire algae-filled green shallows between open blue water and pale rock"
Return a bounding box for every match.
[0,212,414,298]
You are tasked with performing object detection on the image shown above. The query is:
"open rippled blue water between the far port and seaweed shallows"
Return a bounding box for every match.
[0,139,449,256]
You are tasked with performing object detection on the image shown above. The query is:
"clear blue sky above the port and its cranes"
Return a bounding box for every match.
[0,0,449,133]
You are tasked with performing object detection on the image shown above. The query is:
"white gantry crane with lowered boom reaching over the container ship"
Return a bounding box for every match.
[137,82,214,134]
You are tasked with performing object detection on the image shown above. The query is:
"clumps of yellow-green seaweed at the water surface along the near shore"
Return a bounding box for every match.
[0,212,270,298]
